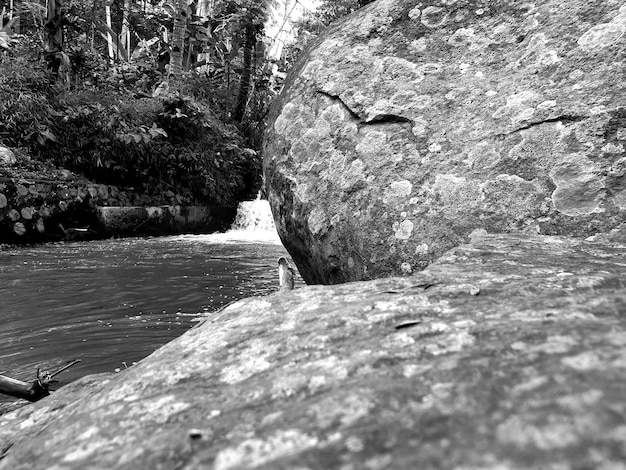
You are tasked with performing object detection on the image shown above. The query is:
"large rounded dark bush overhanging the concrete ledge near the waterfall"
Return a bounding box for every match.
[45,92,260,204]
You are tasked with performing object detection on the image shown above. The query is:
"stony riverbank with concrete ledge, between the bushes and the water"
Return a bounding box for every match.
[0,148,236,244]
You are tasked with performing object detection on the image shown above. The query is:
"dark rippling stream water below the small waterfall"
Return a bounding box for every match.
[0,232,286,401]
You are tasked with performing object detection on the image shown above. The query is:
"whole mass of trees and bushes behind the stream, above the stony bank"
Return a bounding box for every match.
[0,0,371,203]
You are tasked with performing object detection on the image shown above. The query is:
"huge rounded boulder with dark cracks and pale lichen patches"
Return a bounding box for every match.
[264,0,626,283]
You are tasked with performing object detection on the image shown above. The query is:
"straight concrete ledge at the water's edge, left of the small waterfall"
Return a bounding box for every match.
[96,206,237,236]
